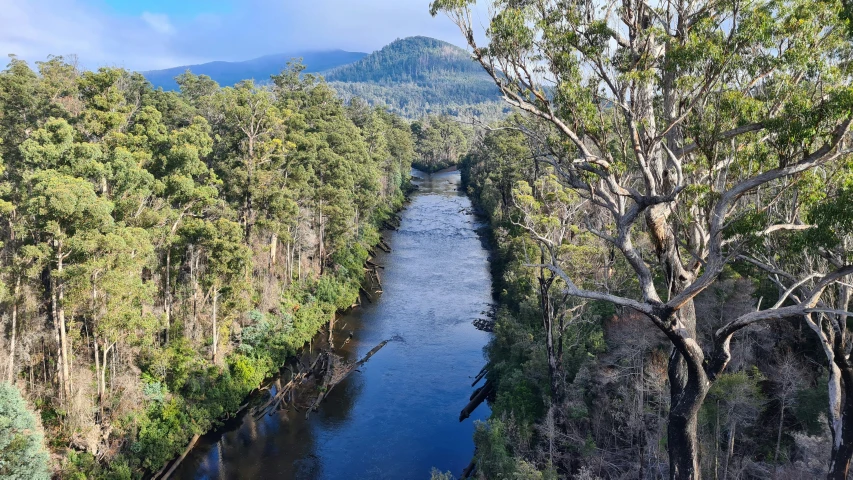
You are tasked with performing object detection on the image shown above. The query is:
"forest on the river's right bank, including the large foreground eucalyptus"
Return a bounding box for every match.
[431,0,853,480]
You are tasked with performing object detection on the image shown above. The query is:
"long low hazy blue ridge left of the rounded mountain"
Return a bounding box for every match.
[142,50,367,90]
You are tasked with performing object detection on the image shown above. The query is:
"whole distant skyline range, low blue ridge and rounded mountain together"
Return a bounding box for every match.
[142,37,509,120]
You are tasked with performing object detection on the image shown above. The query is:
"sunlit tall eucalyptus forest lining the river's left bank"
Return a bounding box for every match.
[0,57,414,479]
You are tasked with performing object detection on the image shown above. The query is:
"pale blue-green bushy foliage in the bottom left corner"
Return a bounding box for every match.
[0,382,50,480]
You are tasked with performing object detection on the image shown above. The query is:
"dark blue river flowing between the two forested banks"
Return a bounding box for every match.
[173,172,491,480]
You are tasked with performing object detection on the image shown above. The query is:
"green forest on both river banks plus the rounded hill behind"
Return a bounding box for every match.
[5,0,853,480]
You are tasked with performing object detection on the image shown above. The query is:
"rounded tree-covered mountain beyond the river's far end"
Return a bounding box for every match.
[323,37,506,118]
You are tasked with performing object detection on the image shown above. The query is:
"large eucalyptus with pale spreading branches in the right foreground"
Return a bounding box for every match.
[431,0,853,478]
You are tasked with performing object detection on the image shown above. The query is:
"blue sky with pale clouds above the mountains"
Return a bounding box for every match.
[0,0,488,70]
